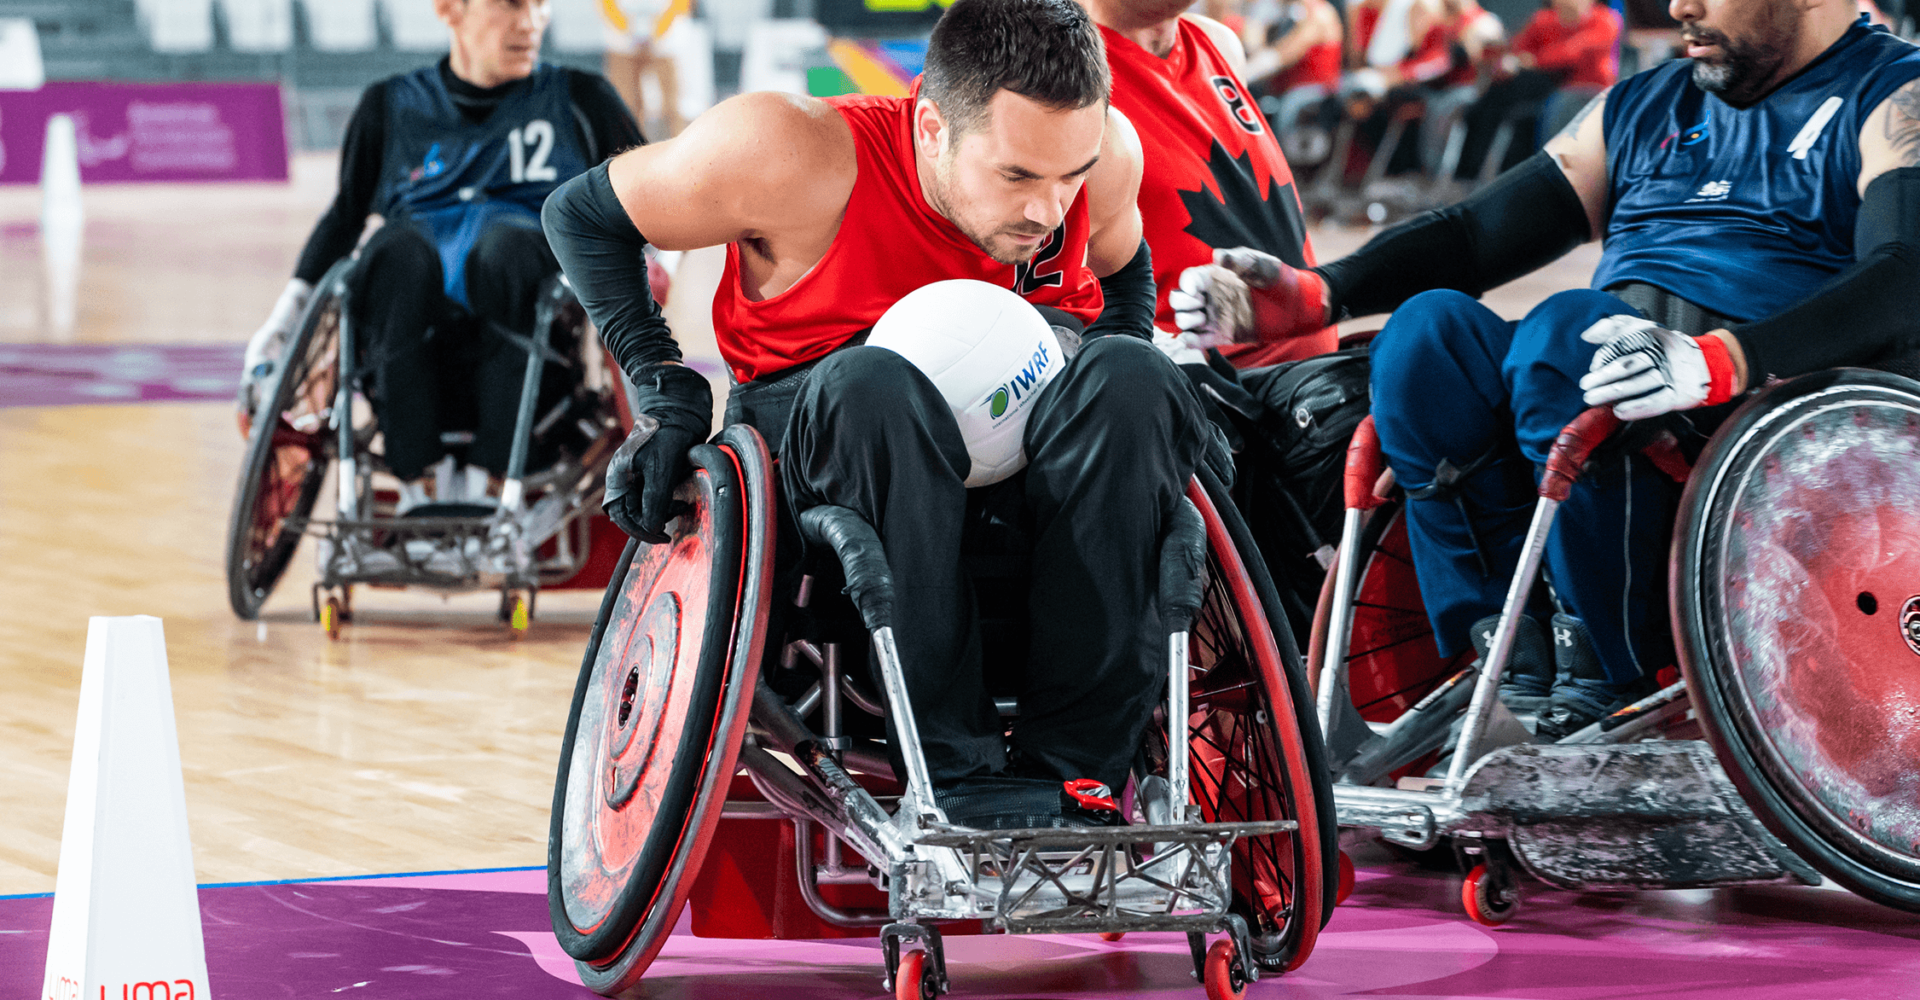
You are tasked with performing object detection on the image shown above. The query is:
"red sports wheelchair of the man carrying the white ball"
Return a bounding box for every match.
[547,424,1338,1000]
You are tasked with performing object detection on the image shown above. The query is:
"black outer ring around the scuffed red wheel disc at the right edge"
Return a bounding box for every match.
[1668,369,1920,912]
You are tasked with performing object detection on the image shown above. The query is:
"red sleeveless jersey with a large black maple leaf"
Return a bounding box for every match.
[1100,17,1334,369]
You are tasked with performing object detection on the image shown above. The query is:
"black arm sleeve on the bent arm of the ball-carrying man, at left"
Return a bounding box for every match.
[540,163,680,378]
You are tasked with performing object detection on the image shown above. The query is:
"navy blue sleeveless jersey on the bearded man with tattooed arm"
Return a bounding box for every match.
[1594,17,1920,322]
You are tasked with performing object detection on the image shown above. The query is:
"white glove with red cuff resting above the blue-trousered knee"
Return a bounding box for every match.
[1580,317,1734,420]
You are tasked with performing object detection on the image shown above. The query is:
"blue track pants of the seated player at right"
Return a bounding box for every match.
[1373,290,1678,685]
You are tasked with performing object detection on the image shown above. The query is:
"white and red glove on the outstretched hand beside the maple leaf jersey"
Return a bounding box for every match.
[1167,246,1327,351]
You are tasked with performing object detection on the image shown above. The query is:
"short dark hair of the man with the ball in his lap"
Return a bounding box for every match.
[920,0,1108,134]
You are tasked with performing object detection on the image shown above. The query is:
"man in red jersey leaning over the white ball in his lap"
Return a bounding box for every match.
[545,0,1212,825]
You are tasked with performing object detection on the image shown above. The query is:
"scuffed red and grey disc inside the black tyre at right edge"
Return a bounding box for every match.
[1715,399,1920,871]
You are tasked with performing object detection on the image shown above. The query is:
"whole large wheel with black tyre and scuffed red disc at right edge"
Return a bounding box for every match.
[1670,370,1920,912]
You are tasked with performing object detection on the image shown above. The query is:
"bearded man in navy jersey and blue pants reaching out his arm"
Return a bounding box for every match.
[1177,0,1920,739]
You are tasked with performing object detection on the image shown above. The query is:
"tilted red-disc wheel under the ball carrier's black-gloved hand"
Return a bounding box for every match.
[547,428,774,996]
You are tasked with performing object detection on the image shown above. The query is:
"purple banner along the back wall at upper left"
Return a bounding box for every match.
[0,83,286,184]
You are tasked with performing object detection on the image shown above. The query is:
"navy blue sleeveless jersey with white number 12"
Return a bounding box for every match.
[372,65,591,305]
